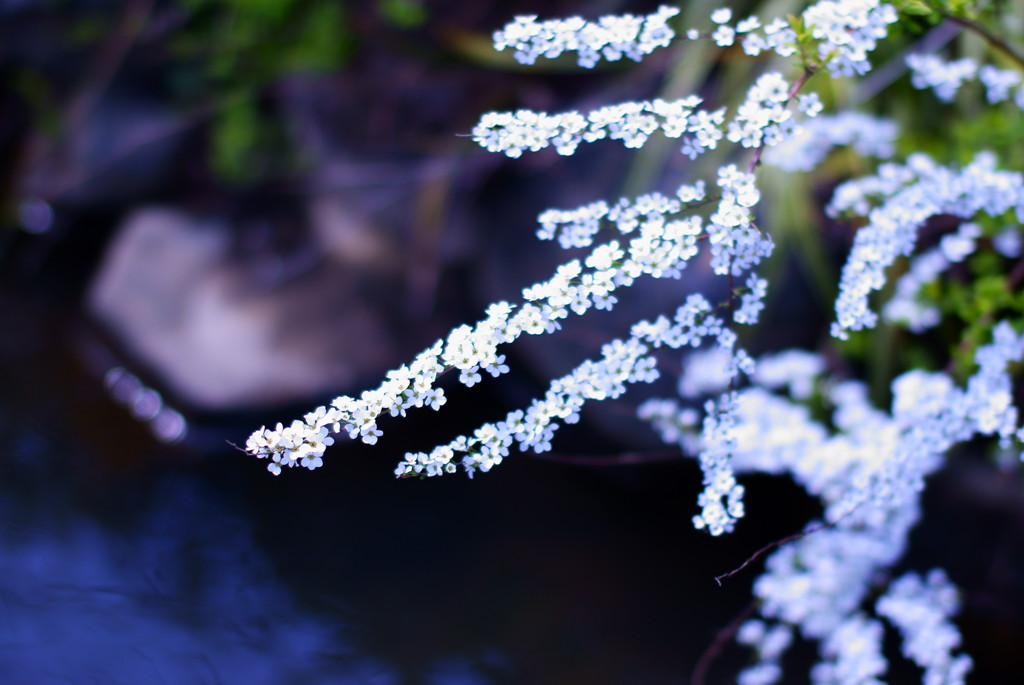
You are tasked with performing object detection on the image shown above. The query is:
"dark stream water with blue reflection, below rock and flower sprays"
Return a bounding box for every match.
[0,296,806,685]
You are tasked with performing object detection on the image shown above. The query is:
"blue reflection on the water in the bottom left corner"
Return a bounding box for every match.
[0,478,389,685]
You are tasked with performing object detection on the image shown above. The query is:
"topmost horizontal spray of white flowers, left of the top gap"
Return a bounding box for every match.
[495,6,679,68]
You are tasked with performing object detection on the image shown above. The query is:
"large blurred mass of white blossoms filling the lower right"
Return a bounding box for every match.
[640,323,1024,685]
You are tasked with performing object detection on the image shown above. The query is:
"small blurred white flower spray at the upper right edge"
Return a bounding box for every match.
[906,53,1024,105]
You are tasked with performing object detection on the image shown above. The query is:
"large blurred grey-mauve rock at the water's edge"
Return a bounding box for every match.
[88,207,396,411]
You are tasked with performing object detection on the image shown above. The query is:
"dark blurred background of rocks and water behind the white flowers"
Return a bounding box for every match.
[0,0,1024,685]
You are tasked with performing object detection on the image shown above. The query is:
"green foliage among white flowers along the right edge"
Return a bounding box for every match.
[831,0,1024,380]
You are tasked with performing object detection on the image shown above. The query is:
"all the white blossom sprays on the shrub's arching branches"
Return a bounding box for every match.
[247,0,1024,685]
